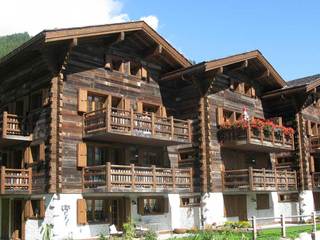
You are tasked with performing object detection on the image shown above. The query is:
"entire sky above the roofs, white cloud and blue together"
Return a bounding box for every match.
[0,0,320,80]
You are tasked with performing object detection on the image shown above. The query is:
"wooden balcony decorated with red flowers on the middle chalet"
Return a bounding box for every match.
[218,122,294,152]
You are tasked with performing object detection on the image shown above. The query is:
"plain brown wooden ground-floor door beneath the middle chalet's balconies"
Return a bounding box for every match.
[223,195,248,221]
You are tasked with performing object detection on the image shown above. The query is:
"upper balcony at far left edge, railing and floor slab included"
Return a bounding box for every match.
[0,112,32,147]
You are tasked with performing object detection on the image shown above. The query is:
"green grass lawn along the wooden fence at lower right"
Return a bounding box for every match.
[171,224,320,240]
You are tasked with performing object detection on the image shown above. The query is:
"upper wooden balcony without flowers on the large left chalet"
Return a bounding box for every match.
[83,107,191,146]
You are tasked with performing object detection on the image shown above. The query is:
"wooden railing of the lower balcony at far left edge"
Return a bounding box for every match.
[0,167,32,194]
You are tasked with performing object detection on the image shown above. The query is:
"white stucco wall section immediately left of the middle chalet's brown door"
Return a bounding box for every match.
[202,192,225,225]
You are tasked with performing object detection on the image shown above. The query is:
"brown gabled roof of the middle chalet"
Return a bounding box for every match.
[162,50,286,88]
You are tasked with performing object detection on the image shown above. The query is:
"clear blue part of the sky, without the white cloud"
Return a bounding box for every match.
[121,0,320,80]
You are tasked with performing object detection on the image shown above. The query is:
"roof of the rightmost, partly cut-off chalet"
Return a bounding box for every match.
[263,74,320,98]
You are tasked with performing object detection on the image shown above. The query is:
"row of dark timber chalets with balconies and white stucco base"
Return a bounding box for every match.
[0,22,320,239]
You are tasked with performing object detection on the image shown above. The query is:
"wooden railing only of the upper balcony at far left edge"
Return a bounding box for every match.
[0,112,30,138]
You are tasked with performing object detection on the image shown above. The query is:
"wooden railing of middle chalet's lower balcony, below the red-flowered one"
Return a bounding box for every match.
[222,168,297,191]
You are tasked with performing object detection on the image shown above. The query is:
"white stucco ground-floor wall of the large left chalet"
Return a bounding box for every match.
[26,194,200,240]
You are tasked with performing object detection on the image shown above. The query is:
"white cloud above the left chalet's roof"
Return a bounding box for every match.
[0,0,159,36]
